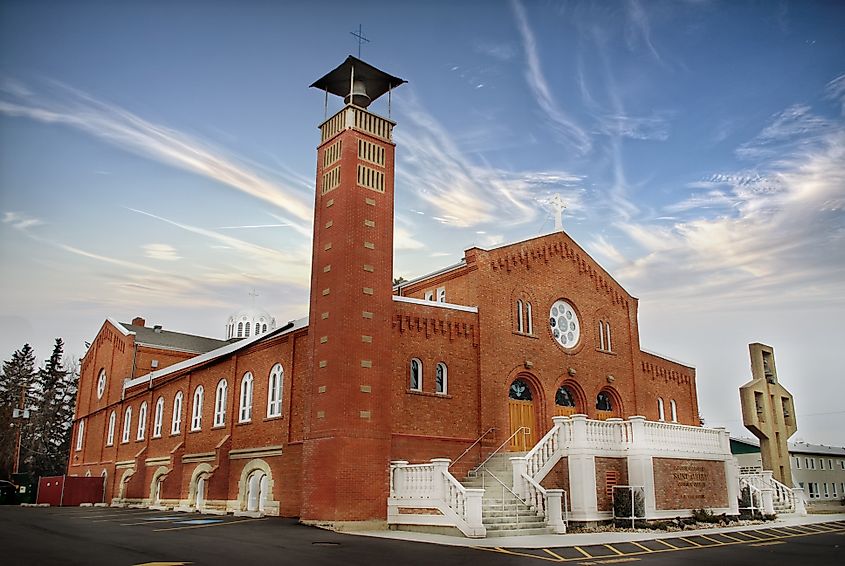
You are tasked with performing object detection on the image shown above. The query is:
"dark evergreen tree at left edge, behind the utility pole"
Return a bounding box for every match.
[0,344,36,479]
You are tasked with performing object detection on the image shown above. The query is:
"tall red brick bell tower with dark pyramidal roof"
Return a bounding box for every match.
[302,55,405,523]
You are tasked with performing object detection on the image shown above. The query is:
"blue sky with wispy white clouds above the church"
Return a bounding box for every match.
[0,0,845,446]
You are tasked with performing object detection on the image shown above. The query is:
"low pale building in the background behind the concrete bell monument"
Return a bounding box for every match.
[731,438,845,502]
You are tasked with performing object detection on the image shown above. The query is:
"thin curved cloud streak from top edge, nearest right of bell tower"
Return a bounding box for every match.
[511,0,592,154]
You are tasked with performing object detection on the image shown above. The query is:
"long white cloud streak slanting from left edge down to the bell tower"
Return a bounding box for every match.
[0,83,312,221]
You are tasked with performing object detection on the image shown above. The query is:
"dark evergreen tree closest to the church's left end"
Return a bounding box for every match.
[27,338,77,476]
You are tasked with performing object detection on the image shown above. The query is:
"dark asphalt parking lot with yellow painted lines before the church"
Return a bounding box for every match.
[0,507,845,566]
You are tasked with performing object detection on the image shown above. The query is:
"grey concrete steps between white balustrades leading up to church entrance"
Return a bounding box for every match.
[461,452,553,538]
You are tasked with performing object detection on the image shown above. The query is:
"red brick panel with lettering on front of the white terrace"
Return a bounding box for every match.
[654,458,728,510]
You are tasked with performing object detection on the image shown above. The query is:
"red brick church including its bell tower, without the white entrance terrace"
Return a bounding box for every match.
[68,56,712,524]
